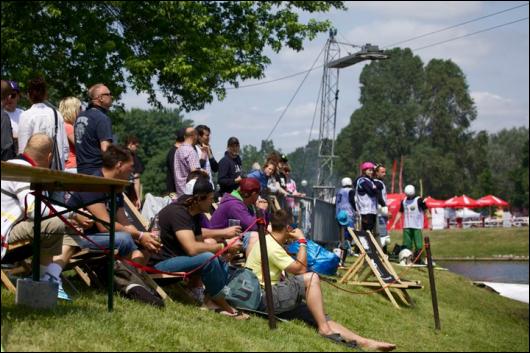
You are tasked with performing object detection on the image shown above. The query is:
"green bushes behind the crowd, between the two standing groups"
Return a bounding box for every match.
[112,109,193,196]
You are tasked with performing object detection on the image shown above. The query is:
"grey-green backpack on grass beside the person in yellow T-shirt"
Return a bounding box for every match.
[225,267,261,310]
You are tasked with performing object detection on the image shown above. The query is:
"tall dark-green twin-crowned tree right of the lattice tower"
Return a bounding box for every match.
[337,48,478,197]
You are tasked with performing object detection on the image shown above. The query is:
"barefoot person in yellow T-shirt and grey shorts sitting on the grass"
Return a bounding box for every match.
[245,210,396,351]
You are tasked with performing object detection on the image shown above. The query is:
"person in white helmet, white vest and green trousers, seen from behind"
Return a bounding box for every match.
[390,185,430,260]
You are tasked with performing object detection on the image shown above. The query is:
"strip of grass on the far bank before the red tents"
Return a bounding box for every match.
[389,227,528,259]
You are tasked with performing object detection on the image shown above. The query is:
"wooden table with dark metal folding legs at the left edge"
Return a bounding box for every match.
[1,162,129,311]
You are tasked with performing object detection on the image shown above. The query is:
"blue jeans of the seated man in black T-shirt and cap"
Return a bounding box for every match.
[155,252,228,298]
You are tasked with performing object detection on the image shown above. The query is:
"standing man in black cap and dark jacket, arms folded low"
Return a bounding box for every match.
[217,137,243,197]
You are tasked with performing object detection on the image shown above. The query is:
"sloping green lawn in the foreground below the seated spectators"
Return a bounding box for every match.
[2,229,529,352]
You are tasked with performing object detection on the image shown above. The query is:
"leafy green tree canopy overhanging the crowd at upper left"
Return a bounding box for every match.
[1,1,344,110]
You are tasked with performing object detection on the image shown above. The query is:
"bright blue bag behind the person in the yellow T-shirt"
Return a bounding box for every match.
[287,240,340,276]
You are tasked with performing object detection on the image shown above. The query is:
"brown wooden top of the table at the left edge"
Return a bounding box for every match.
[1,161,129,192]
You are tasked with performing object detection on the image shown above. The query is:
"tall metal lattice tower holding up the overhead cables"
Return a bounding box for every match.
[316,29,340,195]
